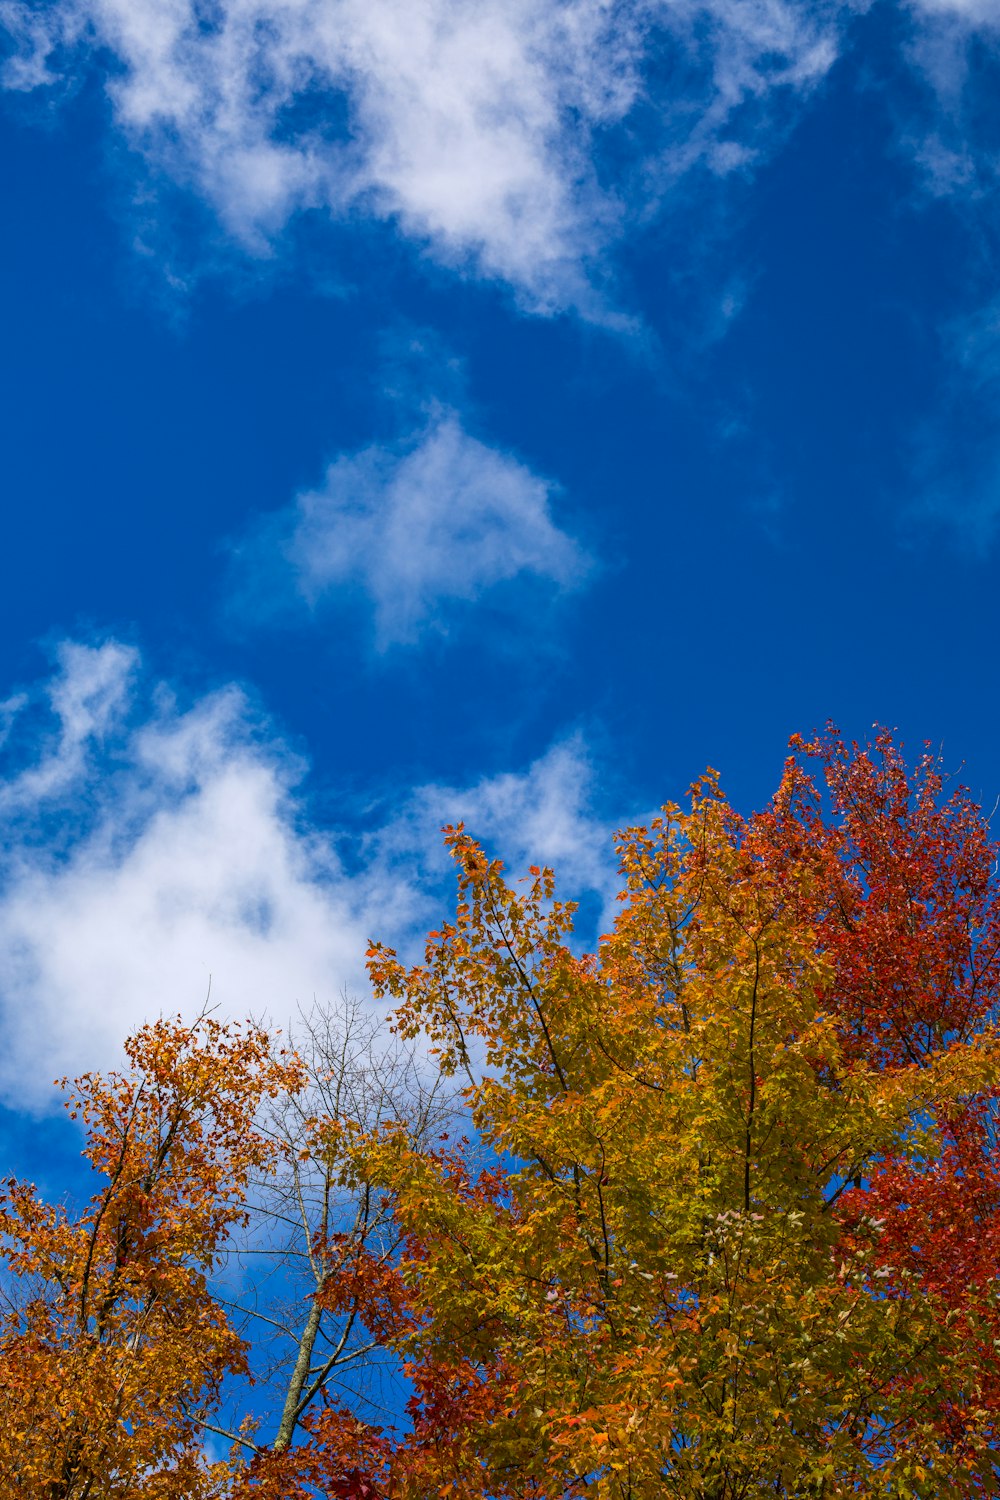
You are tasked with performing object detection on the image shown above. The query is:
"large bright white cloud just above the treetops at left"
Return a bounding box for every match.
[0,642,613,1109]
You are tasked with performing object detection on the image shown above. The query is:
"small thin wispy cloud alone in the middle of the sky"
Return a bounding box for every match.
[240,411,586,650]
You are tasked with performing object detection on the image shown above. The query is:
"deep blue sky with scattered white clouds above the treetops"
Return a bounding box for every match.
[0,0,1000,1152]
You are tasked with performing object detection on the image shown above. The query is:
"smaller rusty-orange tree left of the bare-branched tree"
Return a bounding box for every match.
[0,1016,303,1500]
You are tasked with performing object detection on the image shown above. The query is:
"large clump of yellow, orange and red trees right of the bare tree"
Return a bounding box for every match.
[335,735,1000,1500]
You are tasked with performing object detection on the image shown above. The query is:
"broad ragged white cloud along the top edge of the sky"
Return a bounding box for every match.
[0,0,861,317]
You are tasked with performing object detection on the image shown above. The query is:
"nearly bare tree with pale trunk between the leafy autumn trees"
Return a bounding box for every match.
[211,995,454,1500]
